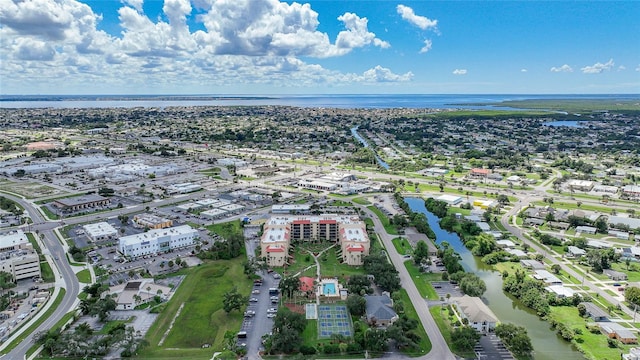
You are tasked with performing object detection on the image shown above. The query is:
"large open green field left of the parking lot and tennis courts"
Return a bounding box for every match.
[140,257,252,359]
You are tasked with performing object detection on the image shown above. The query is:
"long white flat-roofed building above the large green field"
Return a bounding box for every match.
[118,225,198,258]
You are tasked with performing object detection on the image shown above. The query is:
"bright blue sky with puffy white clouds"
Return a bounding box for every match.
[0,0,640,94]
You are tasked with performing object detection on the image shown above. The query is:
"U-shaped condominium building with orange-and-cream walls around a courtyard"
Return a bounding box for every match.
[260,215,369,266]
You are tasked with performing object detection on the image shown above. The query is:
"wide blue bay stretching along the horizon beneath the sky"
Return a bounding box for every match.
[0,94,638,110]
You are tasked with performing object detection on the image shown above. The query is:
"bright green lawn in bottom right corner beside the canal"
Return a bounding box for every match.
[549,306,634,360]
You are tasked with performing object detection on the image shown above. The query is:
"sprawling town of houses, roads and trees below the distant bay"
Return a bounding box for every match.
[0,97,640,359]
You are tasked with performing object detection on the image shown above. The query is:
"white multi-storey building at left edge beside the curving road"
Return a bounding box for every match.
[0,230,40,280]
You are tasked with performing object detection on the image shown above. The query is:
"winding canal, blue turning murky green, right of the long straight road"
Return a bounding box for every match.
[405,198,584,360]
